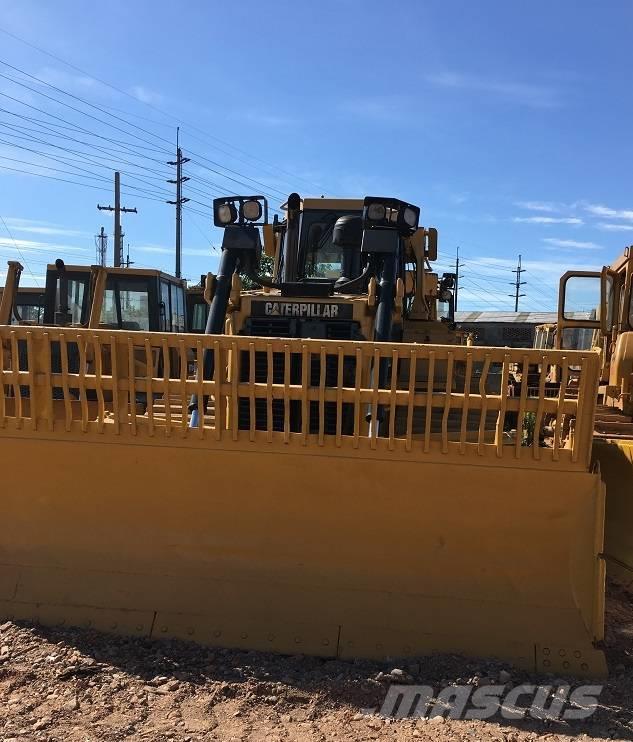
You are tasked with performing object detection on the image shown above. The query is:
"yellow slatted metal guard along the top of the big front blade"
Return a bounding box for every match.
[0,326,600,468]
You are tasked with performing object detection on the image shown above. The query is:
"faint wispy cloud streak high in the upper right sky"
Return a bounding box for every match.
[426,72,561,108]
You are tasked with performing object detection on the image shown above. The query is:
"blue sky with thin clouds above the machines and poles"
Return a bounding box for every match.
[0,0,633,310]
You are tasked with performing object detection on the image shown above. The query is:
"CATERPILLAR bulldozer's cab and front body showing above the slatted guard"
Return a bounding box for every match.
[214,193,456,343]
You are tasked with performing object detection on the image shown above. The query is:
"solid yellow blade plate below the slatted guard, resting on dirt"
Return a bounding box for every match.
[0,439,604,675]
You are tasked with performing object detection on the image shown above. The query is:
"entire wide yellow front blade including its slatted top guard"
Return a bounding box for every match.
[0,327,606,676]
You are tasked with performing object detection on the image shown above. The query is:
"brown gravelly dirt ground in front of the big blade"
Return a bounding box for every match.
[0,586,633,742]
